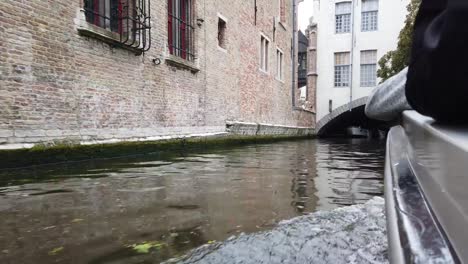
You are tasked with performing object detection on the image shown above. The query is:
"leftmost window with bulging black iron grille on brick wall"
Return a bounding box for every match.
[84,0,151,52]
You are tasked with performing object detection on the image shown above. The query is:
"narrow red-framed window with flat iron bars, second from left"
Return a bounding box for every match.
[167,0,195,61]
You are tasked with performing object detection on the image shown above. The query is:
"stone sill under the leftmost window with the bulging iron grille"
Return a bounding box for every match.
[77,19,142,55]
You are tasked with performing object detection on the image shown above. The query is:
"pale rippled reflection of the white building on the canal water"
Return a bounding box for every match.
[315,139,385,210]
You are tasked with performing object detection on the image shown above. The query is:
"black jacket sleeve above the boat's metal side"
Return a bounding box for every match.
[406,0,468,123]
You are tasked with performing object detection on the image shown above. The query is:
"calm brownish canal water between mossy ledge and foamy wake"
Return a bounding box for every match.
[0,139,385,263]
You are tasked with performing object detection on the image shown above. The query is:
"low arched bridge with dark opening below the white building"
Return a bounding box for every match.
[317,97,391,137]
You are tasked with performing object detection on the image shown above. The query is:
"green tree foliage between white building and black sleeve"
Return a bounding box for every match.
[377,0,421,82]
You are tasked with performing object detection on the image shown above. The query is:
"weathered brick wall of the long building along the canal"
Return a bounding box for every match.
[0,0,312,148]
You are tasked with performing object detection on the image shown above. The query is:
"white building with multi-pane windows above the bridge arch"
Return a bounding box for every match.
[314,0,409,121]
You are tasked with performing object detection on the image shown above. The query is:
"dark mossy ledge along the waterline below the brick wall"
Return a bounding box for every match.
[0,133,314,169]
